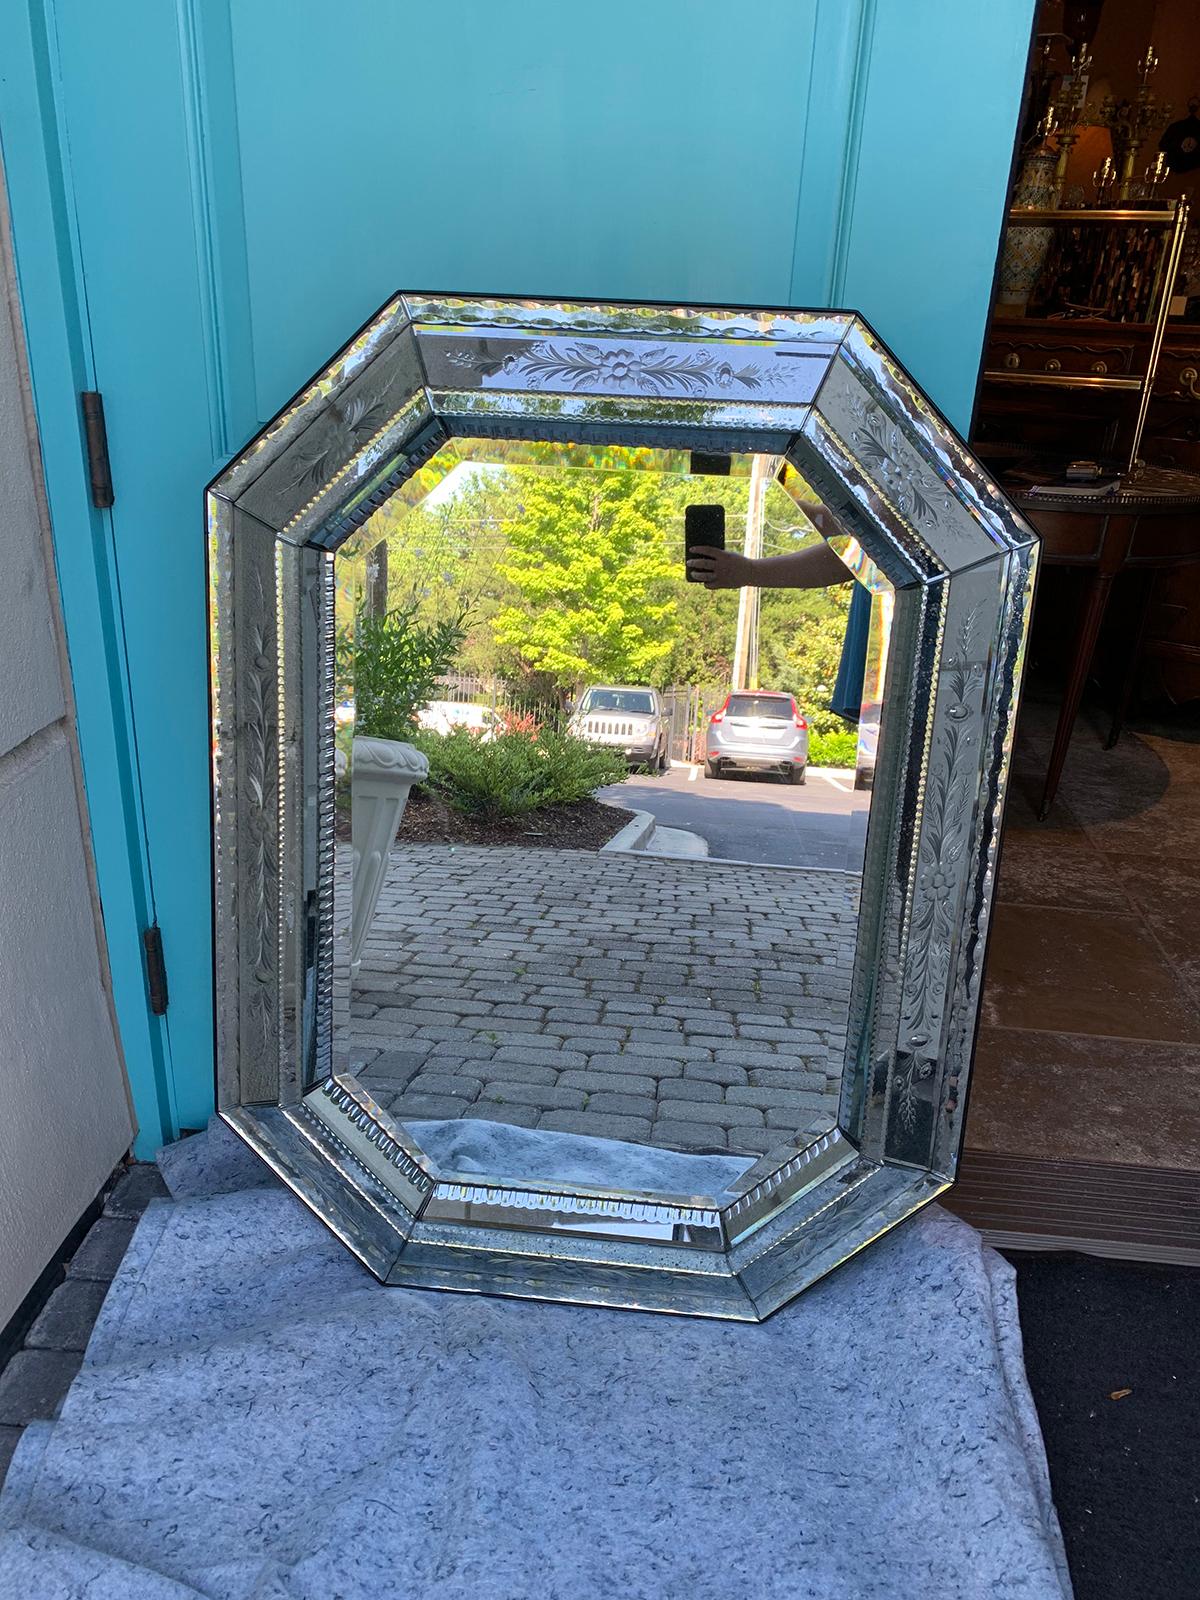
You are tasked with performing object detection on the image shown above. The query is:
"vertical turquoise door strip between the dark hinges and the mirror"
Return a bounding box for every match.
[56,0,222,1126]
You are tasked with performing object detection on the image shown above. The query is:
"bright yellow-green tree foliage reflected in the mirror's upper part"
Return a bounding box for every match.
[356,467,850,713]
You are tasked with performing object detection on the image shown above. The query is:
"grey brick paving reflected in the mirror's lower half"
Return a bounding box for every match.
[346,846,859,1155]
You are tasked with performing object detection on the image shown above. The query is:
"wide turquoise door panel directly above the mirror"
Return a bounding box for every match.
[234,0,829,418]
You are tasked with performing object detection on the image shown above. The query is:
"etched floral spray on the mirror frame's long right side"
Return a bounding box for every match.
[899,605,984,1128]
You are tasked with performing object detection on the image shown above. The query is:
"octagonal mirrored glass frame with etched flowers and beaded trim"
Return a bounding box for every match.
[206,293,1037,1320]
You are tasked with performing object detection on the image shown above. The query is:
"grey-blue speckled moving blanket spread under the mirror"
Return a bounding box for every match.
[0,1126,1070,1600]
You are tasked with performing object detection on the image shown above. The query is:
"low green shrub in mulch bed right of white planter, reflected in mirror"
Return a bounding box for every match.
[411,728,629,818]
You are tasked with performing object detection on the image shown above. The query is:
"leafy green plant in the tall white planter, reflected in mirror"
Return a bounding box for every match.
[338,605,467,739]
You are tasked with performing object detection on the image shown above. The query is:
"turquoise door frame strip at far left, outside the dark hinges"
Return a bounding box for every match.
[0,0,181,1160]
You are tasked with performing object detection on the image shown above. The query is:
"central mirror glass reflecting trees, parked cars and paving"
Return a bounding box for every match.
[321,438,893,1203]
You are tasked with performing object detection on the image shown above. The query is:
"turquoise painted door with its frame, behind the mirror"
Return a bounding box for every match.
[0,0,1032,1154]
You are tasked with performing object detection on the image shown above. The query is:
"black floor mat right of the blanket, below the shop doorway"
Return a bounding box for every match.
[1011,1254,1200,1600]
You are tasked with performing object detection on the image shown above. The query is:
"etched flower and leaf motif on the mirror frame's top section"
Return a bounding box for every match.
[446,339,794,395]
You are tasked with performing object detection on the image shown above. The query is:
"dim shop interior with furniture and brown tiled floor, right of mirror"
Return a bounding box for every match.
[950,0,1200,1262]
